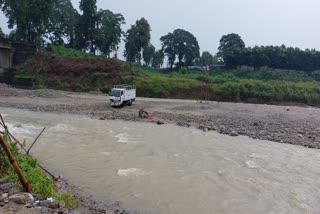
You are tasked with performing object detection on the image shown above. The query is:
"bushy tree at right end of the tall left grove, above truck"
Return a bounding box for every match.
[96,10,125,57]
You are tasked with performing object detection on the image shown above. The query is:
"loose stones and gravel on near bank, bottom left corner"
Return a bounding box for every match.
[0,178,132,214]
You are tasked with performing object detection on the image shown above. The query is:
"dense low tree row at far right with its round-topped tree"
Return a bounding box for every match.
[218,34,320,71]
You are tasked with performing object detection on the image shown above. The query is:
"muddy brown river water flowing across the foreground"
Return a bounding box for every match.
[0,108,320,214]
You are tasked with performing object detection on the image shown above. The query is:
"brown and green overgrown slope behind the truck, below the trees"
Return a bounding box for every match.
[18,47,320,106]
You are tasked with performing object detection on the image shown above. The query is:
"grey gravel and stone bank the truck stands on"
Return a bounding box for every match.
[0,85,320,149]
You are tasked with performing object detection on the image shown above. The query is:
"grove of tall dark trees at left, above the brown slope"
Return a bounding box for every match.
[0,0,125,56]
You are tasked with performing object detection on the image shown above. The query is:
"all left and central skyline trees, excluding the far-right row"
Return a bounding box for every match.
[0,0,213,68]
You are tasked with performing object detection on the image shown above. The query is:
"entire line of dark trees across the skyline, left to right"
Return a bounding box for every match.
[0,0,320,71]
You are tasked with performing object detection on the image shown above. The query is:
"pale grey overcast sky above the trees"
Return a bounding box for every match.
[0,0,320,57]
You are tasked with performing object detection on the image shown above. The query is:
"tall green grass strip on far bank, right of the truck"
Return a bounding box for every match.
[132,65,320,105]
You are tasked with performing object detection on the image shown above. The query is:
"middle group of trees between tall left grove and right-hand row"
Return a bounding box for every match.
[124,26,213,68]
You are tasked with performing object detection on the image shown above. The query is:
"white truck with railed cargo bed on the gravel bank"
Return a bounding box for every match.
[110,85,136,106]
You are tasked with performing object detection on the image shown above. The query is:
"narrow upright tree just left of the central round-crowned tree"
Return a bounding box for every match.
[124,18,151,64]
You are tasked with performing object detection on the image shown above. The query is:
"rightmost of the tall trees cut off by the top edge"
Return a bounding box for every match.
[79,0,97,54]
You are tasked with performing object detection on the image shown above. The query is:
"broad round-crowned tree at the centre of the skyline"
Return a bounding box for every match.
[160,29,200,68]
